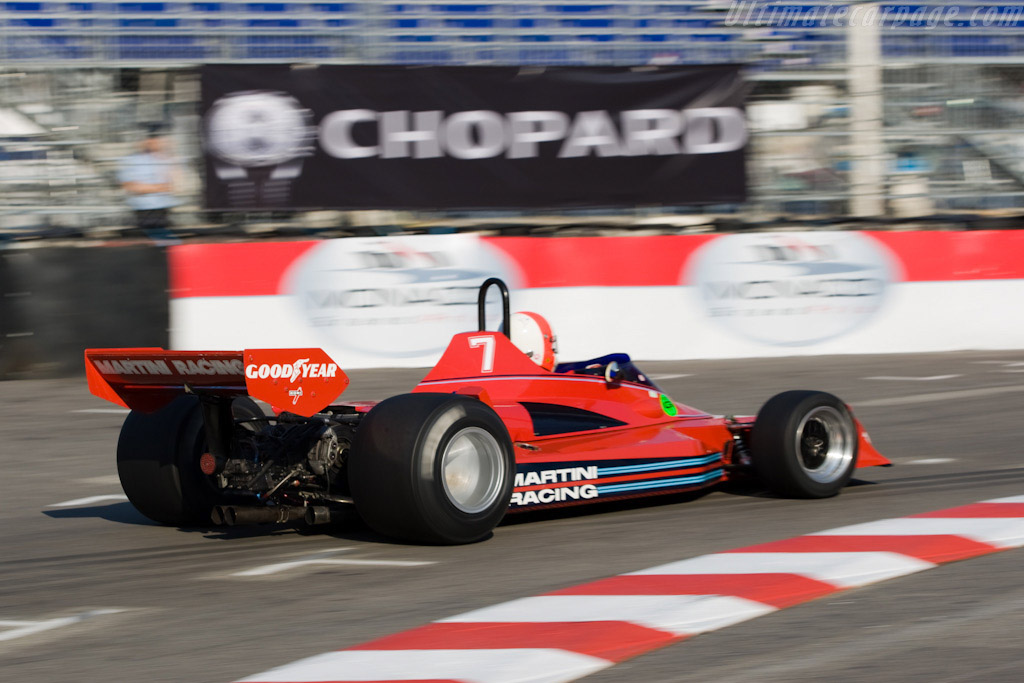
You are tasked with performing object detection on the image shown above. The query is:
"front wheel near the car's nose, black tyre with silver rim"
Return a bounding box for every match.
[751,391,858,498]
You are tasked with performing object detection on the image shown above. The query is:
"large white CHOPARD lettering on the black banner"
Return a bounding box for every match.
[319,106,748,159]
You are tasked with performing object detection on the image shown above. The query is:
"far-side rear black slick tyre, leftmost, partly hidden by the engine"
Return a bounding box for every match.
[118,396,263,526]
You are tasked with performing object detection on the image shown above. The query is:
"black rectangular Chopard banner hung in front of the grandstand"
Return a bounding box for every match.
[202,66,748,209]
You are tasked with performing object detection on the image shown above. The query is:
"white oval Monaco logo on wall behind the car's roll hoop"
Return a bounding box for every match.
[285,234,520,359]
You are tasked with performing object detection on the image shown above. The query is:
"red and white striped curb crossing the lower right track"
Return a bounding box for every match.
[237,496,1024,683]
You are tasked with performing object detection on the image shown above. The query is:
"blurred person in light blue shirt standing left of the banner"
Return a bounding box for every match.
[118,124,179,232]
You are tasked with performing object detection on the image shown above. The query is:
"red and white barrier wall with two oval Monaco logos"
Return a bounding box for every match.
[170,230,1024,368]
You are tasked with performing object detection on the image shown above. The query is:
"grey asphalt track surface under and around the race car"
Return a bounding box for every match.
[0,352,1024,683]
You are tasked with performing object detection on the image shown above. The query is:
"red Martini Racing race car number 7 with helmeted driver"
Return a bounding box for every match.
[85,279,889,544]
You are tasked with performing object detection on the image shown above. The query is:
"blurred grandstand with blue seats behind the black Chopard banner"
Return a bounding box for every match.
[0,0,1024,232]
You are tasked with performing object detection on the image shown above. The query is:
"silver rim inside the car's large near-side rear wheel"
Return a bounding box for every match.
[441,427,505,514]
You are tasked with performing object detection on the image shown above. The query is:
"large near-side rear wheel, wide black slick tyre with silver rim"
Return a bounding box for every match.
[349,393,515,545]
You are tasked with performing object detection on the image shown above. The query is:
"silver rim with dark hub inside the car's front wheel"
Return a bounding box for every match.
[796,405,854,483]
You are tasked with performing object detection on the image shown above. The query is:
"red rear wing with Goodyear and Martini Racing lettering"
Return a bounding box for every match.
[85,347,348,417]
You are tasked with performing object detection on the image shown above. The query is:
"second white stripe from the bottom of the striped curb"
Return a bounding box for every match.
[440,595,775,636]
